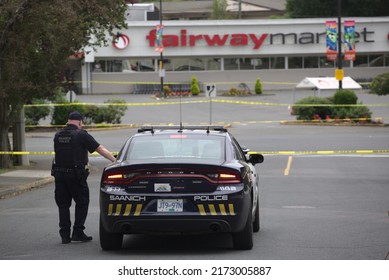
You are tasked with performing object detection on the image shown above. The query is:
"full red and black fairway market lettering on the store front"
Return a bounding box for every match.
[146,27,375,50]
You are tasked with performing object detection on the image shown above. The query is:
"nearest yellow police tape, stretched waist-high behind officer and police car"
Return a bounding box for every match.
[0,150,389,156]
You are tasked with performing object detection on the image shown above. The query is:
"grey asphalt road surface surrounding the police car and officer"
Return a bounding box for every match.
[0,120,389,260]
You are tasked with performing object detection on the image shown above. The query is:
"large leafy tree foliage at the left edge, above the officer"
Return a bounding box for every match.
[0,0,127,168]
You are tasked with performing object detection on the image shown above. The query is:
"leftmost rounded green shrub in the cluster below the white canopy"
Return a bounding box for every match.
[293,96,332,120]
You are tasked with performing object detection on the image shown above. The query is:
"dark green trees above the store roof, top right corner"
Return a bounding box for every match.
[286,0,389,18]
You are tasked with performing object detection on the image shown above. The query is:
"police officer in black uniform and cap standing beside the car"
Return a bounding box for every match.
[53,111,116,244]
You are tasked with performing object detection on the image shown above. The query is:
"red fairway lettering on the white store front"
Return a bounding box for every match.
[146,29,268,50]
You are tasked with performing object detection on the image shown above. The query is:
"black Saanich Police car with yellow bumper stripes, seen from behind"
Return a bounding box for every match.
[100,126,264,250]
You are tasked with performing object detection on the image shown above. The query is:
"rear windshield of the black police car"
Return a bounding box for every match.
[126,133,225,162]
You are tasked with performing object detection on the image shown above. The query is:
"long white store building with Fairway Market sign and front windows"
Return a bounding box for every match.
[79,12,389,94]
